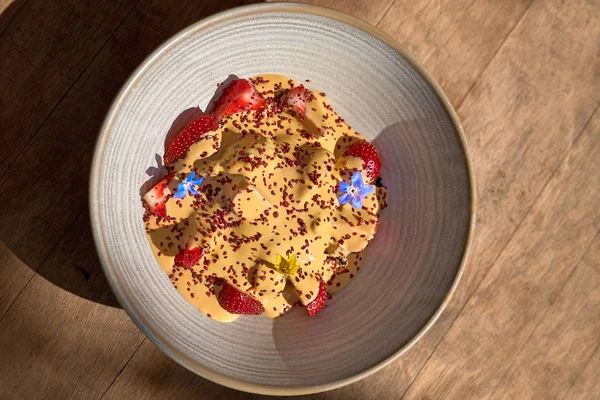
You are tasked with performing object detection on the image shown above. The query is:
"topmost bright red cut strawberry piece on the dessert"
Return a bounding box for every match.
[214,79,265,118]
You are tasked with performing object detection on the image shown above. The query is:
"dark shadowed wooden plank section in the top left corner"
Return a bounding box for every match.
[0,0,137,177]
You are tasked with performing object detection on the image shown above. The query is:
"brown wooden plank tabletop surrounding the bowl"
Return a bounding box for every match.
[0,0,600,399]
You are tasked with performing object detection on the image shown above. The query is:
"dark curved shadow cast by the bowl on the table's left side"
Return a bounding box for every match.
[0,0,257,307]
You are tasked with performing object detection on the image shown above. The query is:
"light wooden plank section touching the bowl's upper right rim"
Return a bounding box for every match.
[378,0,531,106]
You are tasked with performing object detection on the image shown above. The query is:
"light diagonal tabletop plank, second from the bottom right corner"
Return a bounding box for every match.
[405,101,600,399]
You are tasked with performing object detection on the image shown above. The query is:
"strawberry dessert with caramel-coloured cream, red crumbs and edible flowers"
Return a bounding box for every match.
[143,74,387,322]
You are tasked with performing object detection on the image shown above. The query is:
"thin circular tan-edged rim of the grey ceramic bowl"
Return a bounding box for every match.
[89,3,477,396]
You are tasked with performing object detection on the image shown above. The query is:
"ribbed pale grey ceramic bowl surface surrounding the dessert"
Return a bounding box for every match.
[91,5,471,393]
